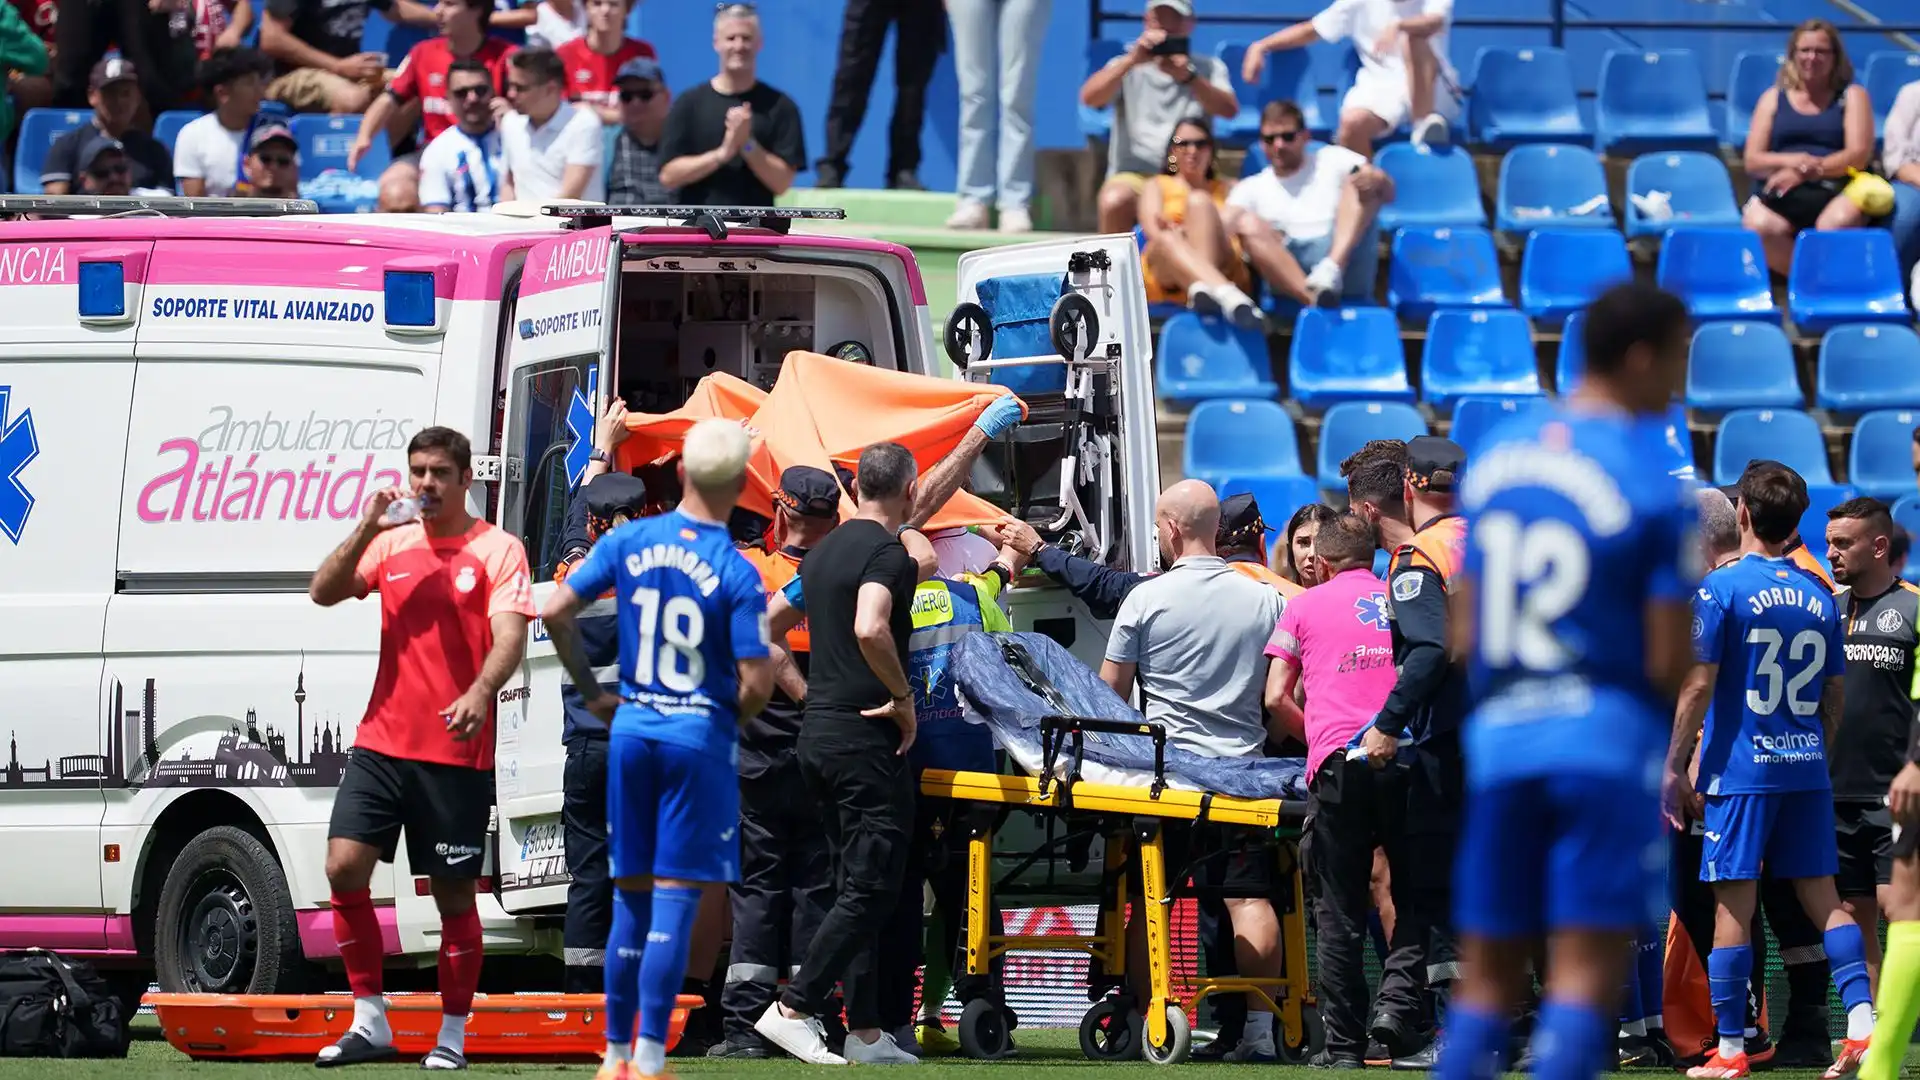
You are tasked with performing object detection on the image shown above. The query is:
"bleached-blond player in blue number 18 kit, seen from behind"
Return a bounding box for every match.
[543,421,774,1080]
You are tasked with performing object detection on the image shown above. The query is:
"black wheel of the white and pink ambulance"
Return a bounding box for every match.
[154,824,305,994]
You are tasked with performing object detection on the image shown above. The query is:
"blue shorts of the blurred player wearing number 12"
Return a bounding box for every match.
[1453,774,1667,940]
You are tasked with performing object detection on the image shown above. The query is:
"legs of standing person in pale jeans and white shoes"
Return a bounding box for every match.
[947,0,1054,233]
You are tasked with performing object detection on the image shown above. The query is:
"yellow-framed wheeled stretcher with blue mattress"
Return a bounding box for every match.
[920,632,1311,1065]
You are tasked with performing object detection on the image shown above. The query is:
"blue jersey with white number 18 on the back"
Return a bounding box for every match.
[566,511,768,748]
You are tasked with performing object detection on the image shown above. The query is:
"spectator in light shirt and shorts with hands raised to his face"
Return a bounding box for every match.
[1081,0,1240,233]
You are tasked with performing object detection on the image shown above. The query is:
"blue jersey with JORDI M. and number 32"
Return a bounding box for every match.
[1693,553,1847,796]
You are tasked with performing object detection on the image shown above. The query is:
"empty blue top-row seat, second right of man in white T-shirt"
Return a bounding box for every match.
[1594,48,1720,154]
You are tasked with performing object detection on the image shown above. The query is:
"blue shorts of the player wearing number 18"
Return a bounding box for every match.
[607,730,739,882]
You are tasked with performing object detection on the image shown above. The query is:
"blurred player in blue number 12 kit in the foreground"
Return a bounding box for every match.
[1436,284,1699,1080]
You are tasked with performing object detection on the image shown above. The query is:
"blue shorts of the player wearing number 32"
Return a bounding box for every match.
[1699,788,1839,882]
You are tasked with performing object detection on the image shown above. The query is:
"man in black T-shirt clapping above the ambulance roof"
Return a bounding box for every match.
[660,4,806,206]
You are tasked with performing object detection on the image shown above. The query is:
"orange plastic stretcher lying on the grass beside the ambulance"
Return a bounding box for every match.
[142,994,705,1061]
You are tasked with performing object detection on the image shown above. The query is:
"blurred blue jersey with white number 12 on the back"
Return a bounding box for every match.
[1459,409,1699,780]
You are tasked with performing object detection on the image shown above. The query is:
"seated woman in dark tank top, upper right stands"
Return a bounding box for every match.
[1741,19,1874,275]
